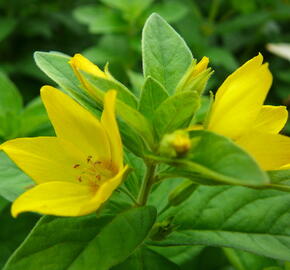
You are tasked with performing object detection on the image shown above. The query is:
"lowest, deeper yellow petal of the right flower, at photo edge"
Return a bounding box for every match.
[236,131,290,170]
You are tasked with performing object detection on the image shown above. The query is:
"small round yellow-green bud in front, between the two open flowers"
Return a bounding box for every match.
[160,130,191,157]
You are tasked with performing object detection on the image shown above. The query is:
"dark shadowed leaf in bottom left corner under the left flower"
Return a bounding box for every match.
[0,204,38,269]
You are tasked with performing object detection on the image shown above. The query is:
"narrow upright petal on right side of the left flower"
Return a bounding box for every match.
[101,90,123,170]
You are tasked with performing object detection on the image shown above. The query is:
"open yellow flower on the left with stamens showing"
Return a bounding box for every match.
[0,86,127,217]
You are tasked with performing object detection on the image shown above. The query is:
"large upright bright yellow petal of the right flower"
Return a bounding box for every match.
[208,54,272,139]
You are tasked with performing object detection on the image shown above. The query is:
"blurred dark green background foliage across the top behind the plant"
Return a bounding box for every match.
[0,0,290,140]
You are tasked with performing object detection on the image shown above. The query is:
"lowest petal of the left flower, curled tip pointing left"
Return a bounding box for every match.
[11,181,96,217]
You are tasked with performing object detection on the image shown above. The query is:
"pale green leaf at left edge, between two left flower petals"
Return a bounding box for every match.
[0,151,33,201]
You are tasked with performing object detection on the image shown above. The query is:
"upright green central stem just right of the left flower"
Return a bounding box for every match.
[138,162,156,205]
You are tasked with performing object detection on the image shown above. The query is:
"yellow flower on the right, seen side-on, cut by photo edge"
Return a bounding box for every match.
[207,54,290,170]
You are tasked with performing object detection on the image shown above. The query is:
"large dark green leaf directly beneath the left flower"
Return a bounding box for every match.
[4,206,156,270]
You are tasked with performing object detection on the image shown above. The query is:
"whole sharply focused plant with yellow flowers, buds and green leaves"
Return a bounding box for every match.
[0,14,290,270]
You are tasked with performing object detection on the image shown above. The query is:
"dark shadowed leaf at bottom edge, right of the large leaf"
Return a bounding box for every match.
[112,247,180,270]
